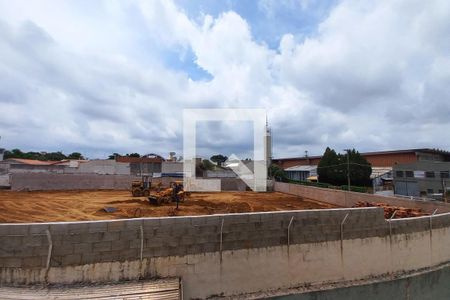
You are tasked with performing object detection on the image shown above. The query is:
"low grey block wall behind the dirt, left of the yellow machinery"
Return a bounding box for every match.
[10,173,139,191]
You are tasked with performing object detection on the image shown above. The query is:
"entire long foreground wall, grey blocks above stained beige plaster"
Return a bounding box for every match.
[0,208,450,299]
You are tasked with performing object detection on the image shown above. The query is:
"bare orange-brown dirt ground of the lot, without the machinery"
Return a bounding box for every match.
[0,190,336,223]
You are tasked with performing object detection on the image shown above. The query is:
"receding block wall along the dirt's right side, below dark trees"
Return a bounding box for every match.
[275,182,450,213]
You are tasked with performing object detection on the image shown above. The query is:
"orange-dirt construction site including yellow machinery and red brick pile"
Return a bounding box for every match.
[0,173,436,223]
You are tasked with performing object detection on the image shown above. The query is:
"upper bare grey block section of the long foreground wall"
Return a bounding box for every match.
[0,208,450,268]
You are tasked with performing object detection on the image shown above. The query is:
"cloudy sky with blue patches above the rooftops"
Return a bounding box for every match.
[0,0,450,158]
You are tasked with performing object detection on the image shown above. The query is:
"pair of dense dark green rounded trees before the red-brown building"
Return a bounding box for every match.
[317,147,372,186]
